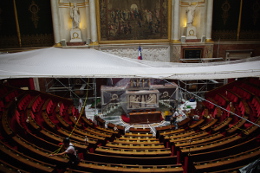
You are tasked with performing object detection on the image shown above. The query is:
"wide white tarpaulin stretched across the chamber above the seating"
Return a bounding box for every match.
[0,47,260,80]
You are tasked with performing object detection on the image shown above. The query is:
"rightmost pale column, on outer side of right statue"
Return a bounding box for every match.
[206,0,213,42]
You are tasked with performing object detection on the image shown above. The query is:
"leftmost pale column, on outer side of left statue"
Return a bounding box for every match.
[50,0,61,46]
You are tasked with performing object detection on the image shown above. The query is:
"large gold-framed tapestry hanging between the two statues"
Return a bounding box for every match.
[99,0,168,41]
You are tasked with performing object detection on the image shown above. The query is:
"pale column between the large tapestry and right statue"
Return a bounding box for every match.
[172,0,180,42]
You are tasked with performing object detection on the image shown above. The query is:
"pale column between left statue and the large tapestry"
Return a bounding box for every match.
[89,0,98,45]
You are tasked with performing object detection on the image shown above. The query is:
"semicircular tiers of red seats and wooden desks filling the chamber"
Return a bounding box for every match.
[0,79,260,172]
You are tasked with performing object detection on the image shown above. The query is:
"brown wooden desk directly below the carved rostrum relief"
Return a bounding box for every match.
[129,111,162,124]
